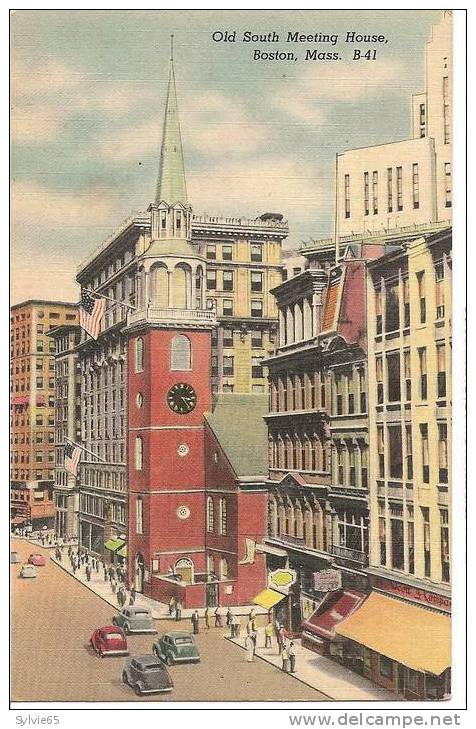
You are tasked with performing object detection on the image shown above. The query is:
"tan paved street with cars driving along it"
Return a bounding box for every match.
[10,539,326,701]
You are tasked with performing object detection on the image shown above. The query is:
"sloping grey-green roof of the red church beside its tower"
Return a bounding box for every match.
[205,393,268,478]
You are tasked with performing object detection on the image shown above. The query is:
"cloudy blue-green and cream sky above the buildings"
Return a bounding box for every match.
[11,10,441,303]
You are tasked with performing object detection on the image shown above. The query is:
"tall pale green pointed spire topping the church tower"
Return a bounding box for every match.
[155,35,187,205]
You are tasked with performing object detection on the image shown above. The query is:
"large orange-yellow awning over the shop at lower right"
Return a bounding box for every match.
[335,592,451,676]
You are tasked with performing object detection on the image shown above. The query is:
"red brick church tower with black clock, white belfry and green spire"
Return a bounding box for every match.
[128,44,216,607]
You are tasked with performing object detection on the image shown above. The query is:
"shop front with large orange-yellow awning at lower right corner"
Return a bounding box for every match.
[335,592,451,701]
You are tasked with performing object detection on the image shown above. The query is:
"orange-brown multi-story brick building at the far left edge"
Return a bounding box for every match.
[10,300,77,526]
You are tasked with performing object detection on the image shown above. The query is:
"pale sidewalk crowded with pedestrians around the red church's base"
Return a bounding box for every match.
[50,550,267,626]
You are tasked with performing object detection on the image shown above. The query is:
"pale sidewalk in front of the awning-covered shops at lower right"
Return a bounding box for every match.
[226,631,397,701]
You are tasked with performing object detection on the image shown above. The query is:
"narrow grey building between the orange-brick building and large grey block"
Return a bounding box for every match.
[48,324,81,538]
